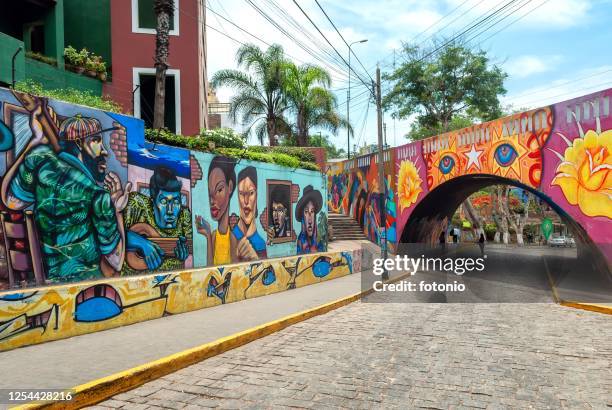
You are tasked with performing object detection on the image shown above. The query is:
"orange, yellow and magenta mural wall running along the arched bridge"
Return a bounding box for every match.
[328,89,612,263]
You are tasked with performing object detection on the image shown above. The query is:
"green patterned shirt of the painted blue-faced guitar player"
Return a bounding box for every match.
[121,192,192,276]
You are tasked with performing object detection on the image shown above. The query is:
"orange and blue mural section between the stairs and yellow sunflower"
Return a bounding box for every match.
[327,151,397,252]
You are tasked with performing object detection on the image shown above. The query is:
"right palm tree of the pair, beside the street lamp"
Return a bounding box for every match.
[284,62,352,147]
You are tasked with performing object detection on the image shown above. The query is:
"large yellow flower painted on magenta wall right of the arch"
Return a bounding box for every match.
[552,130,612,219]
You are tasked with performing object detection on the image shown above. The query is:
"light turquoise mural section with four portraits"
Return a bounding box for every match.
[191,152,327,266]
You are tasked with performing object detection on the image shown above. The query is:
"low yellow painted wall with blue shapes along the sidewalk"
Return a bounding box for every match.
[0,250,362,351]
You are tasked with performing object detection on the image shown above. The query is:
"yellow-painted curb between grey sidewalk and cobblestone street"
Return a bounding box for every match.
[12,273,410,410]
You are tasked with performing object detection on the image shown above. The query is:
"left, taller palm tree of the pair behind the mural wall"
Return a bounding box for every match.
[212,44,287,146]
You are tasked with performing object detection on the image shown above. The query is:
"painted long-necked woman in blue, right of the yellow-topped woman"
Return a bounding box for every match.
[232,166,268,262]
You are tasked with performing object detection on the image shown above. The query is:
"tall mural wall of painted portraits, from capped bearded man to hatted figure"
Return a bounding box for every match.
[0,89,327,291]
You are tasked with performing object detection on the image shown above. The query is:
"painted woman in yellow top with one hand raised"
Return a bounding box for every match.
[196,156,238,266]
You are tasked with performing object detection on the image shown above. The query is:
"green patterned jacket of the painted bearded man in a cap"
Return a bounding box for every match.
[11,145,121,282]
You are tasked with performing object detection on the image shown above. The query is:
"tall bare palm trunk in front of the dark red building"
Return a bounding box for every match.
[153,0,174,129]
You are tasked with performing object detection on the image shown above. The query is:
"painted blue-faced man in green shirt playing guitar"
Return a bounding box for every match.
[121,166,192,275]
